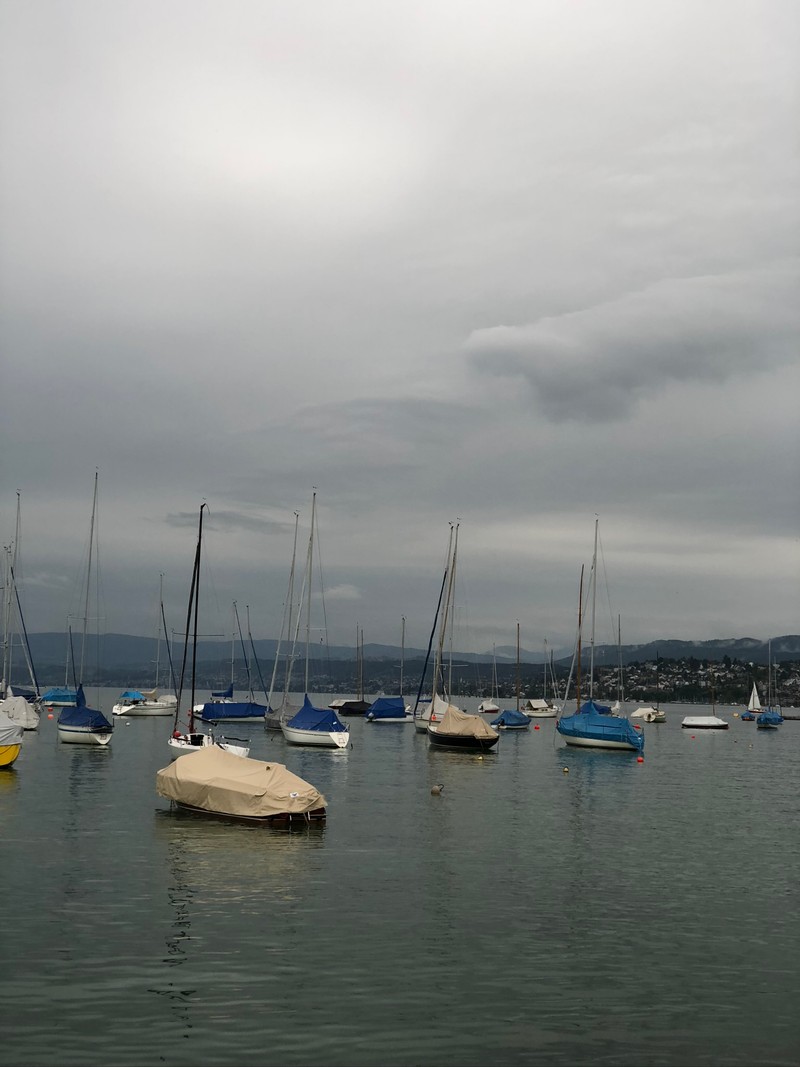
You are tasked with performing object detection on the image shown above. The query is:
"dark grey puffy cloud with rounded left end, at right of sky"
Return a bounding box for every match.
[466,260,800,421]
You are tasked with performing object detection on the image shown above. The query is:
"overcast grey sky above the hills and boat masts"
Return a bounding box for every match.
[0,0,800,651]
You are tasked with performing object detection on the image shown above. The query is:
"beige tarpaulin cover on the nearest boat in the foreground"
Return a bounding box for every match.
[156,745,325,818]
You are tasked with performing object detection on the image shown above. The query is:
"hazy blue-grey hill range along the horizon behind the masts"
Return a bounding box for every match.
[20,633,800,678]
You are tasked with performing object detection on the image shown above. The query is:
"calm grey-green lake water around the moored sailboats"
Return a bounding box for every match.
[0,689,800,1067]
